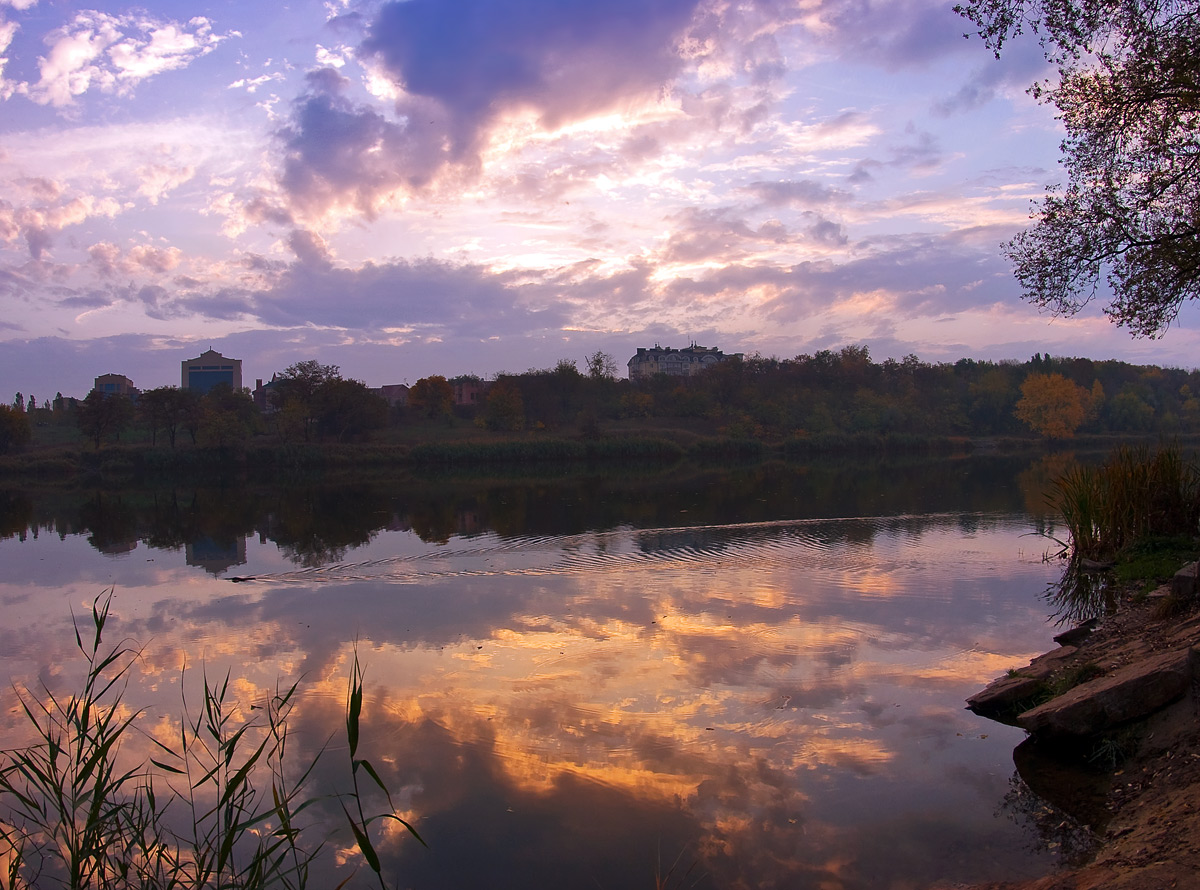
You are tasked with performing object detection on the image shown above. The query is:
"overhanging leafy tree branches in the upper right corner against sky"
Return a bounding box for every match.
[955,0,1200,337]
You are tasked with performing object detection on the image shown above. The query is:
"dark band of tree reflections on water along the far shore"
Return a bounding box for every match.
[0,457,1065,566]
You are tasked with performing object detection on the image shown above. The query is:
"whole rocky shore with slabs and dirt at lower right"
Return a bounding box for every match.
[967,564,1200,890]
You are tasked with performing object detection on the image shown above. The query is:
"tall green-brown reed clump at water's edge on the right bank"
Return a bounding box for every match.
[1051,446,1200,563]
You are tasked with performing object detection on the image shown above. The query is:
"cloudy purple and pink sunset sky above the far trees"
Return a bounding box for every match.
[0,0,1200,401]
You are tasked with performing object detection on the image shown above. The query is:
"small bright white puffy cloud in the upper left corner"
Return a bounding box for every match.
[17,10,226,108]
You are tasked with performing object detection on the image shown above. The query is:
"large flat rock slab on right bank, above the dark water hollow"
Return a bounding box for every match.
[1016,649,1196,738]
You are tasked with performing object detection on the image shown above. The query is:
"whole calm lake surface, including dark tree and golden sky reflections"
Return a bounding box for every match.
[0,457,1084,890]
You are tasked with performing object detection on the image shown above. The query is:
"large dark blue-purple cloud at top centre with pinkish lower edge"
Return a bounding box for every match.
[281,0,698,216]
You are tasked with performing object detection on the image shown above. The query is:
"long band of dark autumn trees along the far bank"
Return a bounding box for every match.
[0,345,1200,451]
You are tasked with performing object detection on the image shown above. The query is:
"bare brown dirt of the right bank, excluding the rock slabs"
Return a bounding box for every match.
[971,592,1200,890]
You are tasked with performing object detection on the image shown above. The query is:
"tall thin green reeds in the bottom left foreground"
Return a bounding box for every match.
[0,590,424,890]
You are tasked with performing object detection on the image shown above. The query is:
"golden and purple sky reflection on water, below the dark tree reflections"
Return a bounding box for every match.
[0,513,1056,888]
